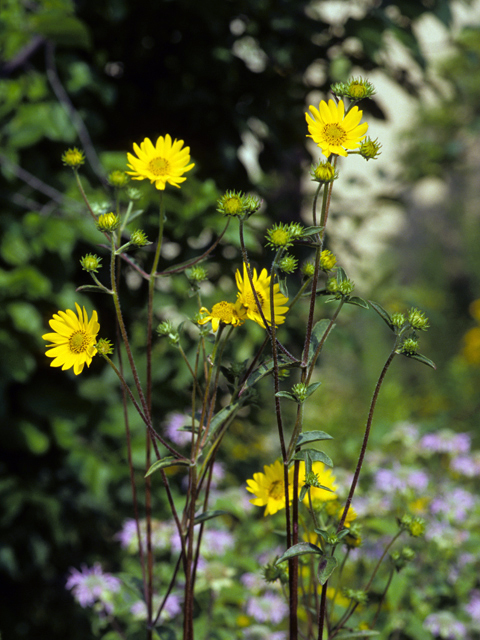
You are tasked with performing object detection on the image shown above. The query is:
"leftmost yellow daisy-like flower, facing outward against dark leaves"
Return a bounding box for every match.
[42,303,100,376]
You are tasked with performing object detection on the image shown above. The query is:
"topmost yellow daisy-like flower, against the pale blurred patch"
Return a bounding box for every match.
[305,100,368,158]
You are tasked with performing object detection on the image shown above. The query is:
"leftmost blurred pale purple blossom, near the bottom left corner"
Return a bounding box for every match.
[65,562,121,613]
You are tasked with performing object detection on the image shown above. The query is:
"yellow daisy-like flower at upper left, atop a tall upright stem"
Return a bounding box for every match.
[126,133,195,191]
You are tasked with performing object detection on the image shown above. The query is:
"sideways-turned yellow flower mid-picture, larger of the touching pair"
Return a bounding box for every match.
[235,263,288,328]
